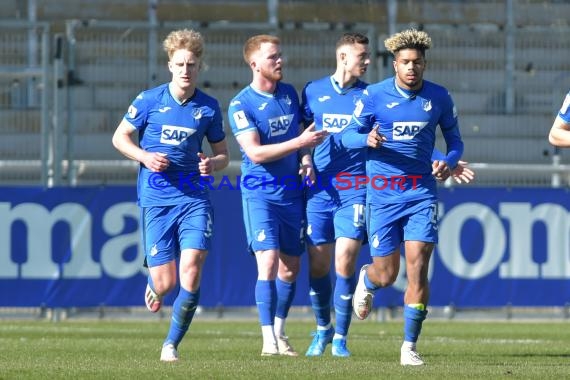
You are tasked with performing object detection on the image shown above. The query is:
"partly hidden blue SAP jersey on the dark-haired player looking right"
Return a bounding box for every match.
[301,76,367,199]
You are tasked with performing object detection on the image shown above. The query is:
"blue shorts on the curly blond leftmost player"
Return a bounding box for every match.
[141,199,213,267]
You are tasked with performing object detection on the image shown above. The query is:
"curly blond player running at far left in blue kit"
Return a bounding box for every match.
[113,29,229,362]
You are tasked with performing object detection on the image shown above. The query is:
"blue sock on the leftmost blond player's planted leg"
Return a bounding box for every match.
[164,287,200,347]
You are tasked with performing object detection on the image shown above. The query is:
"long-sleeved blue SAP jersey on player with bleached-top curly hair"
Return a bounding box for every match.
[343,77,463,203]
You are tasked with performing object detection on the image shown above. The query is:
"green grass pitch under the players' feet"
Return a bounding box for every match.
[0,319,570,380]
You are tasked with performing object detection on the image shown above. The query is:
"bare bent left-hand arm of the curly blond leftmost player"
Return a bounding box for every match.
[112,119,170,172]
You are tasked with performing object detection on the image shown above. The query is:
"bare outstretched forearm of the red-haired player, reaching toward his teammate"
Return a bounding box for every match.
[236,125,327,164]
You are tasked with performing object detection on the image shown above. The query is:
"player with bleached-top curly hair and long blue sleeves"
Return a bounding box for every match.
[342,29,463,366]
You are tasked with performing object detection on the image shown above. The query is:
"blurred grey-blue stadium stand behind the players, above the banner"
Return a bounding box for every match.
[0,0,570,185]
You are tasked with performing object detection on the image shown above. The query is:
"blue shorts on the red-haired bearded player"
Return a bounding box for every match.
[242,198,305,256]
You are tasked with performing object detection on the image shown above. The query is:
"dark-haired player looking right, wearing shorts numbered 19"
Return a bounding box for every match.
[302,32,370,357]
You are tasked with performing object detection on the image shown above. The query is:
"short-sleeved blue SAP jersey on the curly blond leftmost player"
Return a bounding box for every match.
[124,83,225,207]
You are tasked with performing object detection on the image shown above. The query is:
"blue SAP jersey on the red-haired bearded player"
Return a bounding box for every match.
[228,82,303,200]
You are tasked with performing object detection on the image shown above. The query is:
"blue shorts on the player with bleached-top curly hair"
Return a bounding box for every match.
[366,199,438,256]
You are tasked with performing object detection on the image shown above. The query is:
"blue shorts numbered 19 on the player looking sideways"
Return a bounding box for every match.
[307,197,366,245]
